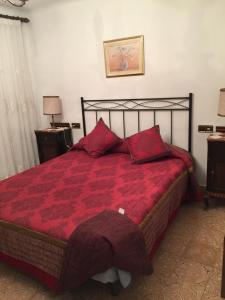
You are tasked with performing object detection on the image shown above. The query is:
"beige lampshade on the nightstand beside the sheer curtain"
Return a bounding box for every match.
[43,96,62,115]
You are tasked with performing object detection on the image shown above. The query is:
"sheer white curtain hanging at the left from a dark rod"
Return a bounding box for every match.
[0,18,38,179]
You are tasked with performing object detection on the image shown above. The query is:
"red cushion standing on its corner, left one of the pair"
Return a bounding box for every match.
[79,118,120,157]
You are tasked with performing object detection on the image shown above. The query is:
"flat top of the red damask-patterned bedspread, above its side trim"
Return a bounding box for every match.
[0,146,191,241]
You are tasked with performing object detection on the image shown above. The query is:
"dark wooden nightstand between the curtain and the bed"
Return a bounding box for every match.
[35,127,73,163]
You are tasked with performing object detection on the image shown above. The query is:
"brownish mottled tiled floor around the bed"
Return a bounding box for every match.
[0,204,225,300]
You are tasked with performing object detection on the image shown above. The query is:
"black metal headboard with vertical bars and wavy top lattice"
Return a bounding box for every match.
[81,93,192,152]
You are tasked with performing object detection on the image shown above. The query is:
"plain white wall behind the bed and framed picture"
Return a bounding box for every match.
[23,0,225,184]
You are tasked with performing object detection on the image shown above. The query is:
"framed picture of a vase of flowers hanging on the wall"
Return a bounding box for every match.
[103,35,144,77]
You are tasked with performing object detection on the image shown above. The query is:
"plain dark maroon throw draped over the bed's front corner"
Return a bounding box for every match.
[60,210,153,291]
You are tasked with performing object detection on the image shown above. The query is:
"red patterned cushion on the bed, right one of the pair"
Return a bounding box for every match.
[127,126,170,163]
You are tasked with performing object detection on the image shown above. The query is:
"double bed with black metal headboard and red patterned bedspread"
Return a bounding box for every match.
[0,94,197,291]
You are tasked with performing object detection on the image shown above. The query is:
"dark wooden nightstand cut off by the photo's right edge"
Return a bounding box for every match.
[205,134,225,206]
